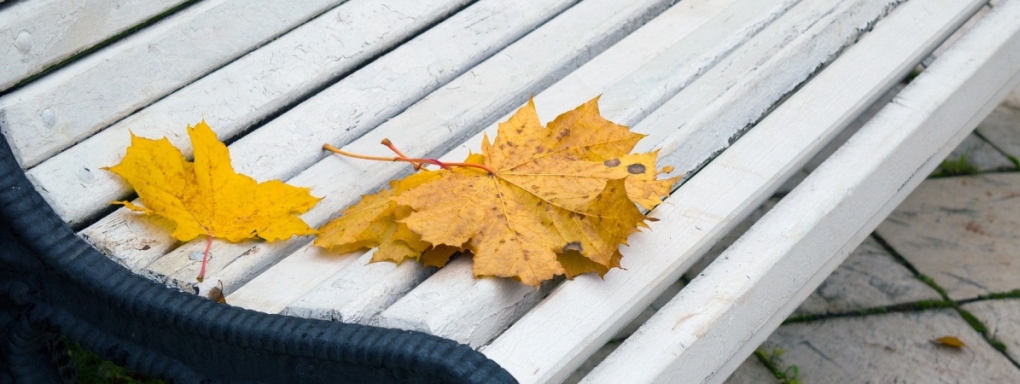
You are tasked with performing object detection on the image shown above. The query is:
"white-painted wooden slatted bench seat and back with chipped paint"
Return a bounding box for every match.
[0,0,1020,383]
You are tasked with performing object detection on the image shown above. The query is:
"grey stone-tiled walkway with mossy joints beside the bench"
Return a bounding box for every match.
[727,90,1020,383]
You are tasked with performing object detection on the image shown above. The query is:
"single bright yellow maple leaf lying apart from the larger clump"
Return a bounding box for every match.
[105,122,319,281]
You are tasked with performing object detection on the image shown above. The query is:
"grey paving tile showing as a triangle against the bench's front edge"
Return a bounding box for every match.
[794,237,941,315]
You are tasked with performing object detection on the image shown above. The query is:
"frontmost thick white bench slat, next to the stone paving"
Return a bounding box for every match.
[584,0,1020,383]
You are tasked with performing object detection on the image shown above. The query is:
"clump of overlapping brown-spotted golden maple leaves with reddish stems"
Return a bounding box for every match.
[316,98,677,286]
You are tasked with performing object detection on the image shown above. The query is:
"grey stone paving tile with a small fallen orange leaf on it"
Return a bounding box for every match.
[762,309,1020,383]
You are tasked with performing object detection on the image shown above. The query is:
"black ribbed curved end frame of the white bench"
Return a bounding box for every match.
[0,132,515,383]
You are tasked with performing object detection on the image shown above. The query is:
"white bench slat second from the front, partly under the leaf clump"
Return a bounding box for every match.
[481,0,981,383]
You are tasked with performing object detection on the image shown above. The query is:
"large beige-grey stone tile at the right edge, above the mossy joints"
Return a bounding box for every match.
[876,173,1020,299]
